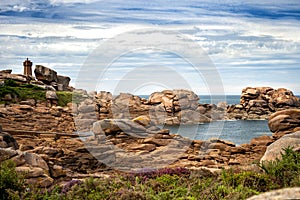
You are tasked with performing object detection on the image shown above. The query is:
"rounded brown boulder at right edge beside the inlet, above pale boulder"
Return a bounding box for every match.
[268,109,300,133]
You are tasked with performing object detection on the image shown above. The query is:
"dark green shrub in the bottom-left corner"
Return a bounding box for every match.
[0,160,24,200]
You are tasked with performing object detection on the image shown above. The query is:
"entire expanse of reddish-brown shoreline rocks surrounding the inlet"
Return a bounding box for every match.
[0,66,300,187]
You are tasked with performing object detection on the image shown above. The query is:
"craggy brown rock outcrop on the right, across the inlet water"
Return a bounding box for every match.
[227,87,300,119]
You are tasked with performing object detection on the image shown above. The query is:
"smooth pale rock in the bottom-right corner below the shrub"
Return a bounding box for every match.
[247,187,300,200]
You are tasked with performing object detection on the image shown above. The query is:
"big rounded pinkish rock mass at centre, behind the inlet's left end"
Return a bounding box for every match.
[147,90,218,125]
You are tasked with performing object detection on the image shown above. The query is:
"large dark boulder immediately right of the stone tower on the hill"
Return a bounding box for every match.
[34,65,58,85]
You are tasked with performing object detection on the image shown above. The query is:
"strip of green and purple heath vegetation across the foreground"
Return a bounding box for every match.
[0,148,300,200]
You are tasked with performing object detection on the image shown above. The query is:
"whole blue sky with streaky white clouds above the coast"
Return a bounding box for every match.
[0,0,300,95]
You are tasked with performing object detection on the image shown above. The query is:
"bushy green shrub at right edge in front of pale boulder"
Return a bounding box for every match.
[259,147,300,187]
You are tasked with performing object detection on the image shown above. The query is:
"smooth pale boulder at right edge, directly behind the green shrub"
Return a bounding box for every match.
[260,131,300,162]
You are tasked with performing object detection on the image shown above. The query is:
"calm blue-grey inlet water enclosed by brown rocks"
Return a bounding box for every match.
[163,120,272,145]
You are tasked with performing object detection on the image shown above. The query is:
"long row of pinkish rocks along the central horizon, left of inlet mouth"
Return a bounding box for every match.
[81,90,217,125]
